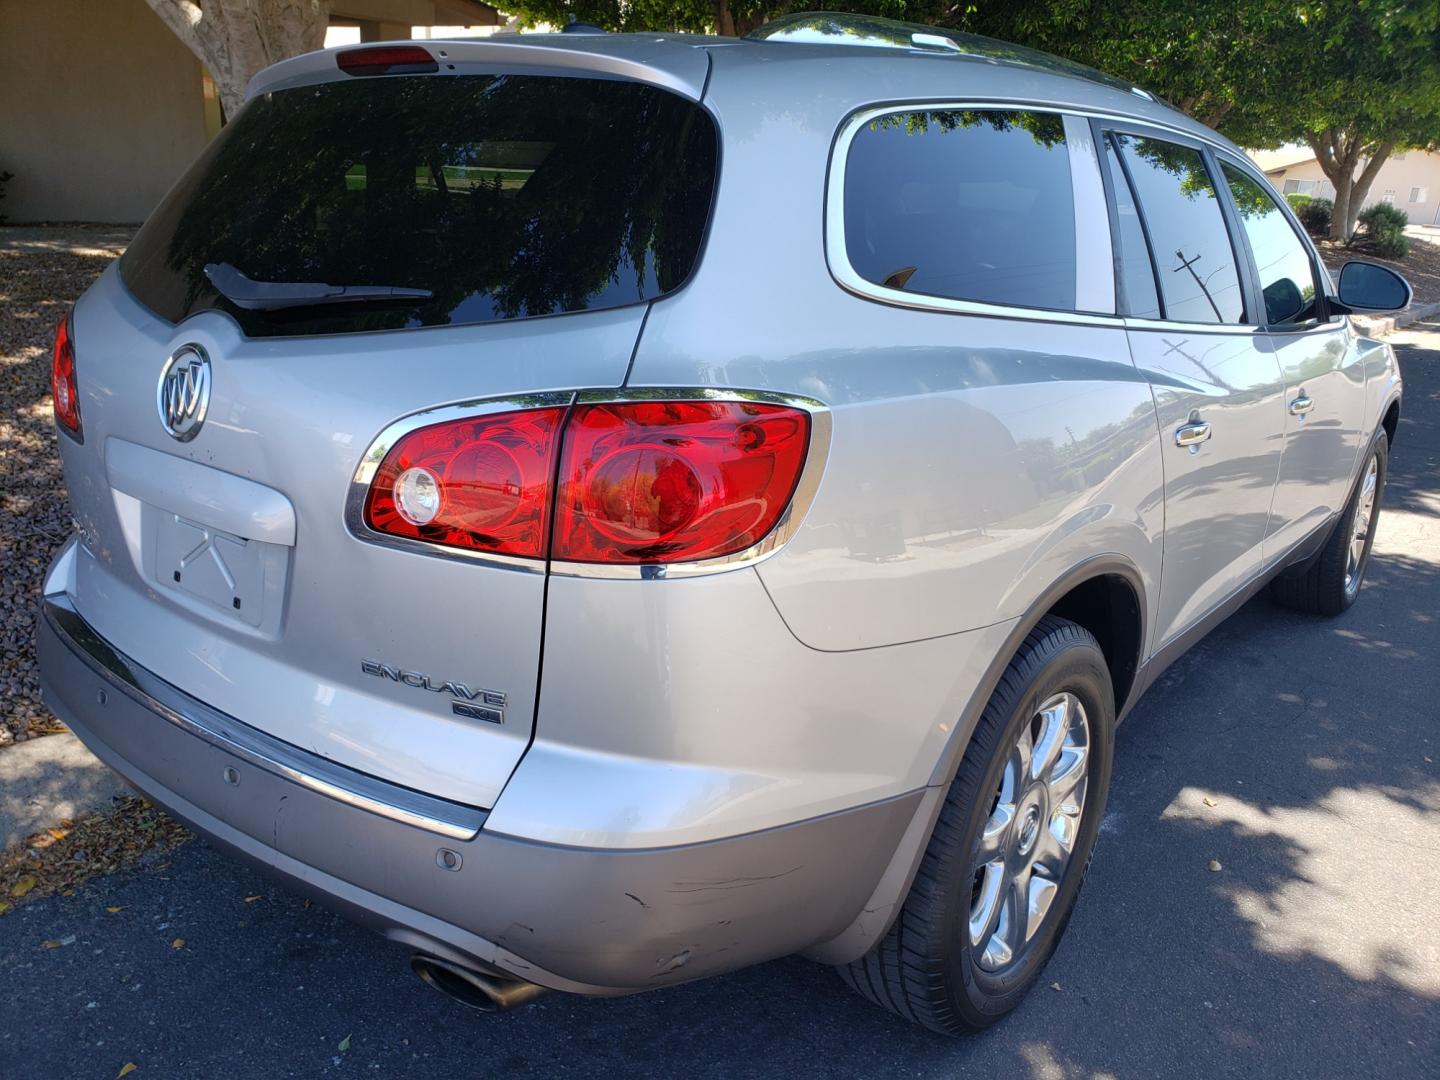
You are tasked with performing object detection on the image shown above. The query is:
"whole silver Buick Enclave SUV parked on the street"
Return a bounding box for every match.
[40,16,1408,1031]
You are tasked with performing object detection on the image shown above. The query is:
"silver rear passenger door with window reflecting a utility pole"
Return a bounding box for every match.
[1104,125,1284,648]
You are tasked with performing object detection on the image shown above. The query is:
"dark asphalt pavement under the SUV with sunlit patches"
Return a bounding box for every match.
[0,323,1440,1080]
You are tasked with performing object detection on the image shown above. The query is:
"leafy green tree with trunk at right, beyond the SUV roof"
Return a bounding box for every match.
[942,0,1440,240]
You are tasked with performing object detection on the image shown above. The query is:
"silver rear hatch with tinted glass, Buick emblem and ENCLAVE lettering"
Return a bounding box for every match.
[60,55,716,806]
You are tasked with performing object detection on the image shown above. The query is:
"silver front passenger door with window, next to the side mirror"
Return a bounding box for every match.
[1220,158,1365,564]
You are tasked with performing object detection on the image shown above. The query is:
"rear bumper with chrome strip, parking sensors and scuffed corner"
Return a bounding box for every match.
[39,593,920,994]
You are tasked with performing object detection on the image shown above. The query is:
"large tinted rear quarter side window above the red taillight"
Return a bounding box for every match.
[844,109,1076,311]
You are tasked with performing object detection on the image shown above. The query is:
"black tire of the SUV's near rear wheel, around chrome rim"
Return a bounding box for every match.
[840,616,1115,1034]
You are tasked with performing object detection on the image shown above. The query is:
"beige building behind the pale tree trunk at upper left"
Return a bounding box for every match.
[0,0,504,223]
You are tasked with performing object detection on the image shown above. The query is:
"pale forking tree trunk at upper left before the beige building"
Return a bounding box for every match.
[145,0,330,117]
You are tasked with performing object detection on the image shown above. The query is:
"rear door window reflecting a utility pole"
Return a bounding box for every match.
[1112,134,1244,323]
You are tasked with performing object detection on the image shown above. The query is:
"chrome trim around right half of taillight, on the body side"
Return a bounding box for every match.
[550,386,832,580]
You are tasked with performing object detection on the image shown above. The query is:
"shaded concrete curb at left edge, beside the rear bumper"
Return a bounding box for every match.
[0,732,130,848]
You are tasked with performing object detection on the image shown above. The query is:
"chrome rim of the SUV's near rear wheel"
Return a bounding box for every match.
[966,693,1090,972]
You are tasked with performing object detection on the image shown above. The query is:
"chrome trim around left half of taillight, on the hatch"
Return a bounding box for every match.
[344,390,575,573]
